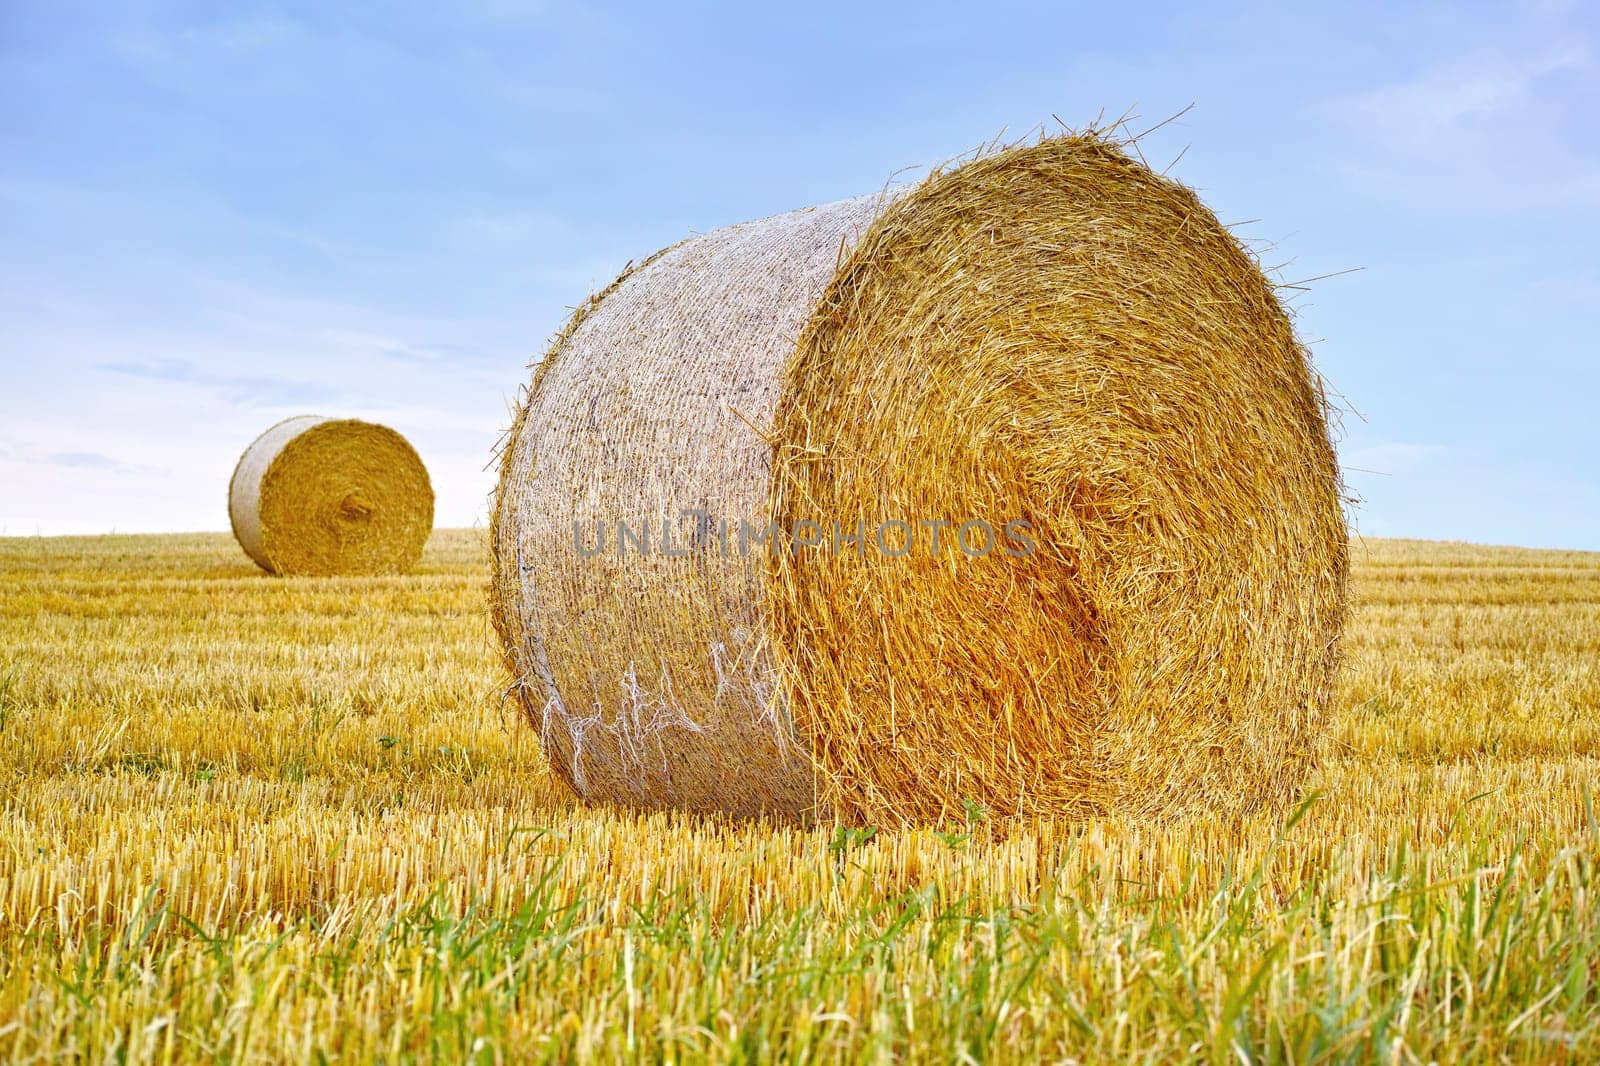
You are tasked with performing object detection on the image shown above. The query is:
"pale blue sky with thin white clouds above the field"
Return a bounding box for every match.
[0,0,1600,549]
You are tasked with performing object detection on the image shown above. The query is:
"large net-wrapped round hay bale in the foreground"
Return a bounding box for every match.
[491,134,1347,824]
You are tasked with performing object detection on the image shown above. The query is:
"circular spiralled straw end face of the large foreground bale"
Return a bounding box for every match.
[766,138,1347,823]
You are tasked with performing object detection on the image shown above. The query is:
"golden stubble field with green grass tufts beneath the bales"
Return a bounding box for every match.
[0,531,1600,1063]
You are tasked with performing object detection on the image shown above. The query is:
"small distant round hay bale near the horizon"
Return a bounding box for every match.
[227,415,434,576]
